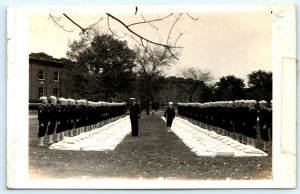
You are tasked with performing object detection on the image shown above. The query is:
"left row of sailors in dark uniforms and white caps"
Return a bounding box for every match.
[38,96,126,146]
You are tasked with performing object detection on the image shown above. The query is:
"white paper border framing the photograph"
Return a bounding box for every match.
[7,4,297,189]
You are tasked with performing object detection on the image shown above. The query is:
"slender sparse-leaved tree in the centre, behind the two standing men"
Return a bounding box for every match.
[136,45,174,114]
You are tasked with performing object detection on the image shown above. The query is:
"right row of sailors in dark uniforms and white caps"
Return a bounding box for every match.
[178,100,272,151]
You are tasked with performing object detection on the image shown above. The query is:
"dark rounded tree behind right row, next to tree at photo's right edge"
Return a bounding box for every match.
[215,75,245,100]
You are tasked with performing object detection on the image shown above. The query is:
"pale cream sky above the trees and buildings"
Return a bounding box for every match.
[29,11,272,81]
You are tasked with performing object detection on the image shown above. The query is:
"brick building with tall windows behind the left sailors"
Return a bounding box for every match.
[29,53,69,102]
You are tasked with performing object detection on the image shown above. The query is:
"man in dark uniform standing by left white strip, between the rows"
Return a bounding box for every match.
[130,98,141,136]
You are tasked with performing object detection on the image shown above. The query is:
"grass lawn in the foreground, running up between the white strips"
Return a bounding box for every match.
[29,112,272,180]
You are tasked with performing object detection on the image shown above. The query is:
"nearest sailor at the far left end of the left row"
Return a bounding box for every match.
[38,96,49,147]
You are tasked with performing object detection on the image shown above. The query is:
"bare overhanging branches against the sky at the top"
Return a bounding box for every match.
[49,11,198,59]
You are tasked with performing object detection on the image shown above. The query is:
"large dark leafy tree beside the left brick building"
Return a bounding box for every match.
[67,34,136,101]
